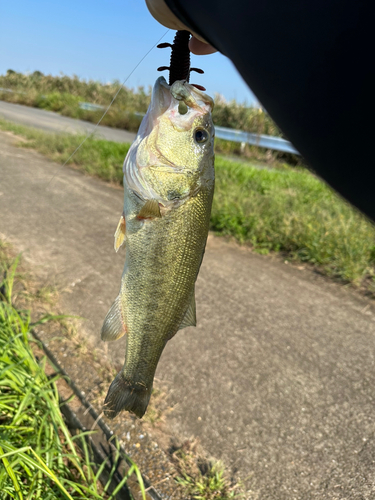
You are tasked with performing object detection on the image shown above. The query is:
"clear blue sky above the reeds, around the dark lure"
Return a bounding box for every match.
[0,0,255,104]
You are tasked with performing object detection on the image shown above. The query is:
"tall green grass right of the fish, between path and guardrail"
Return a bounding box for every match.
[211,158,375,292]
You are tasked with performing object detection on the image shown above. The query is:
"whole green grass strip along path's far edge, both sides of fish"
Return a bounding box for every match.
[0,121,375,293]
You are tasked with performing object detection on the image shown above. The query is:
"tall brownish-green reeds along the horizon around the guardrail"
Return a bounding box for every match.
[0,70,294,165]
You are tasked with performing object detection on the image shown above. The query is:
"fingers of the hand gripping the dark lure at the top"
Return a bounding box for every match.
[146,0,217,56]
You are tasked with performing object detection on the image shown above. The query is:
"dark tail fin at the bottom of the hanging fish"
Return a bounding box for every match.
[104,372,152,418]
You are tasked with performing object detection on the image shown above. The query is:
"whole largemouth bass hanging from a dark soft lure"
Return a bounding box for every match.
[102,77,215,418]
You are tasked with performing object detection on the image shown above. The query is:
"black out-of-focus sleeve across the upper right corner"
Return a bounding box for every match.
[166,0,375,219]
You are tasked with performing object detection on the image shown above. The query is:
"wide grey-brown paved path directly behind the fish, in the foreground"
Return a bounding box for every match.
[0,133,375,500]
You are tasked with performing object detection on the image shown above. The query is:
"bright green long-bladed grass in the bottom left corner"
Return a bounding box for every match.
[0,245,145,500]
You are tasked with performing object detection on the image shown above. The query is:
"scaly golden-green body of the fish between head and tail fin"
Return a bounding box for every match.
[123,186,212,366]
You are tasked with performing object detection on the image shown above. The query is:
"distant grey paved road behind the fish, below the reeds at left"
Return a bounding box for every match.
[0,101,135,142]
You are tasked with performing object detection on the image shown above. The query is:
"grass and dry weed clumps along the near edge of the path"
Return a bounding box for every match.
[0,240,243,500]
